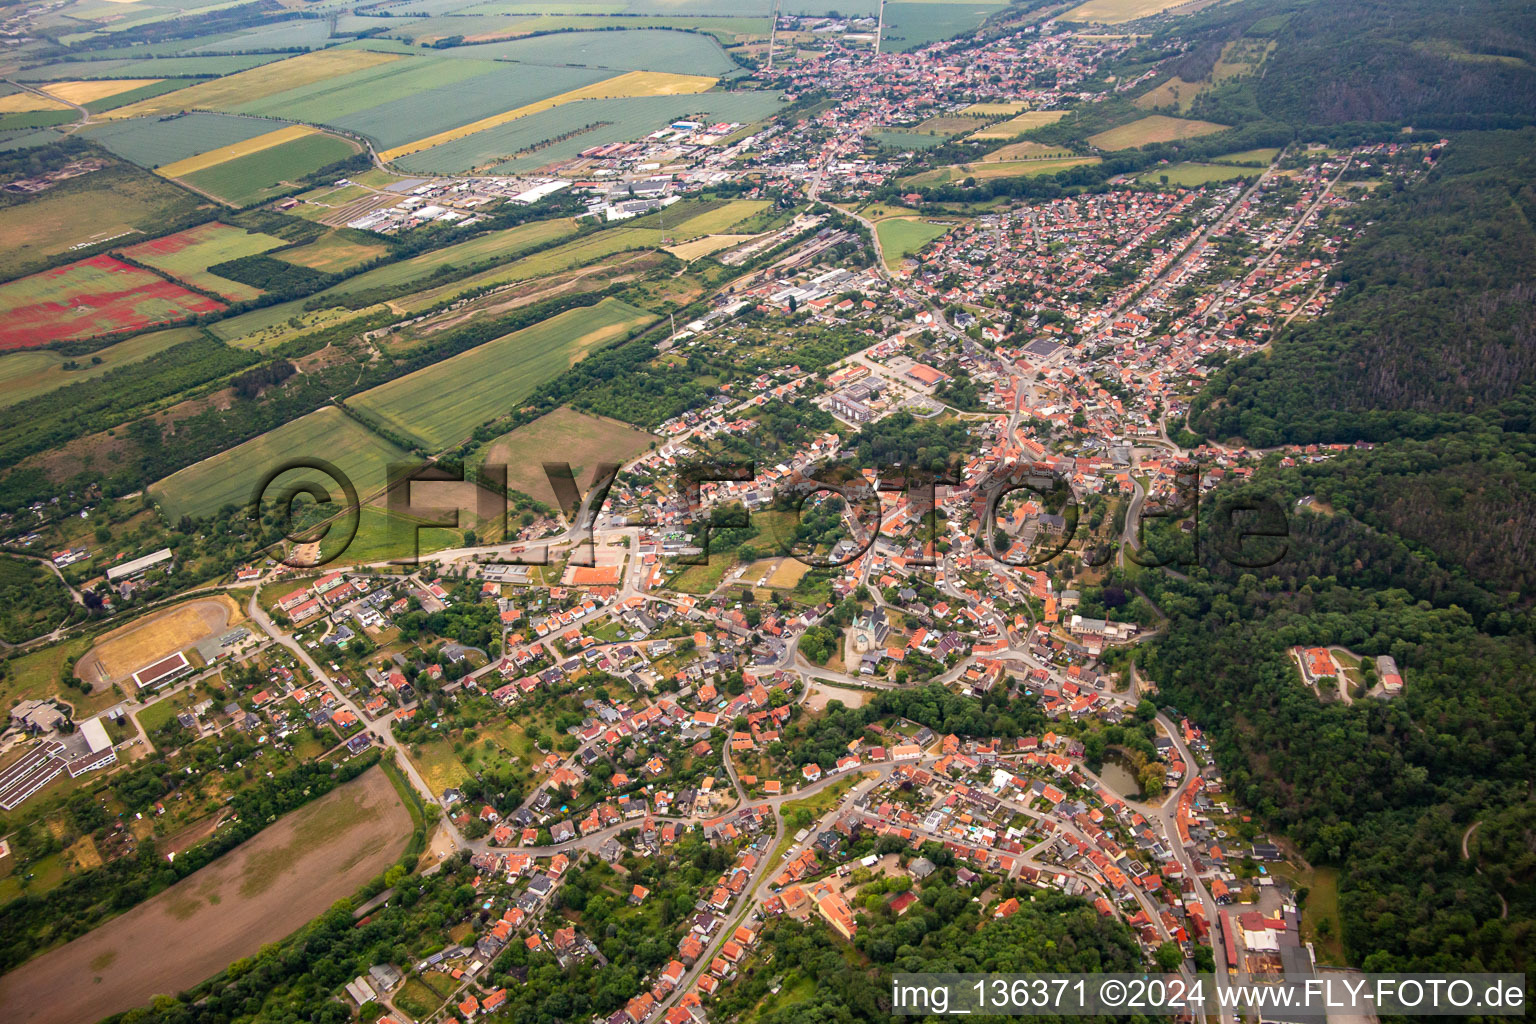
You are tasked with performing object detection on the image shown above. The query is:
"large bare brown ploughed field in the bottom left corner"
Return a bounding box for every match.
[0,768,410,1024]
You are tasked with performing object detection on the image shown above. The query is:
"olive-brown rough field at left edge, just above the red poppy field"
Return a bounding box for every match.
[0,163,207,278]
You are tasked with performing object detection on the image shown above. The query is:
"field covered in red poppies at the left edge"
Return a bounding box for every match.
[0,256,224,352]
